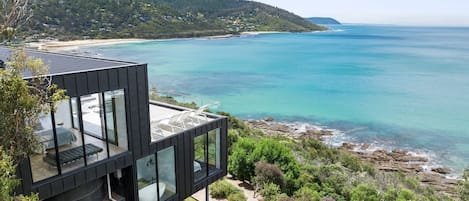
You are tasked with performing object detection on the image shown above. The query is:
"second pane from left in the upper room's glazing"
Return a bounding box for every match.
[54,100,85,173]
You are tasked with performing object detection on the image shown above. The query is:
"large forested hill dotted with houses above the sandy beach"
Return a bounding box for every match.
[22,0,326,40]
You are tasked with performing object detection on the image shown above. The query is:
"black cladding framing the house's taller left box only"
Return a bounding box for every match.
[16,65,150,199]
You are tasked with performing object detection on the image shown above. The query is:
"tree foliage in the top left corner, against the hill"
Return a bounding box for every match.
[0,0,32,40]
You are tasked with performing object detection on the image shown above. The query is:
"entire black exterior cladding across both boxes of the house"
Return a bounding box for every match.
[15,64,228,200]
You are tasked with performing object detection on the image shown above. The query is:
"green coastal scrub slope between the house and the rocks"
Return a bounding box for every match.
[151,96,469,201]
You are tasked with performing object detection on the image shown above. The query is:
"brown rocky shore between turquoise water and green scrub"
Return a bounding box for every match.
[245,118,458,197]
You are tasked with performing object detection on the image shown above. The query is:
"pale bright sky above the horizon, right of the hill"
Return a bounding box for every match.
[256,0,469,26]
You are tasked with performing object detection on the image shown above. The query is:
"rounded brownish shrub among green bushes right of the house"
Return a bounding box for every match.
[254,161,285,189]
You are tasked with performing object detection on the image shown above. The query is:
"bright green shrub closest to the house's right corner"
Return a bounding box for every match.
[228,138,256,181]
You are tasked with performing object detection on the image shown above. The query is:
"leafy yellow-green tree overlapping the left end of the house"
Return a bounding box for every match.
[0,49,65,164]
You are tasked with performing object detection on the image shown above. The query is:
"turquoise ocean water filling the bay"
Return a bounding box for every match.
[86,25,469,172]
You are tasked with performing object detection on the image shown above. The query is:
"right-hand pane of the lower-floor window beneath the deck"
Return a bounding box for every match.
[157,147,176,200]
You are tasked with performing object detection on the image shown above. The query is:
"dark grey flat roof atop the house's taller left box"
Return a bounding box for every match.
[0,46,138,77]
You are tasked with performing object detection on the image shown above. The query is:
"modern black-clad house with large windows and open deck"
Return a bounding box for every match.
[0,47,228,201]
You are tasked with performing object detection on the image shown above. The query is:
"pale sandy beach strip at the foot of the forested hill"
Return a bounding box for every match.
[26,31,287,52]
